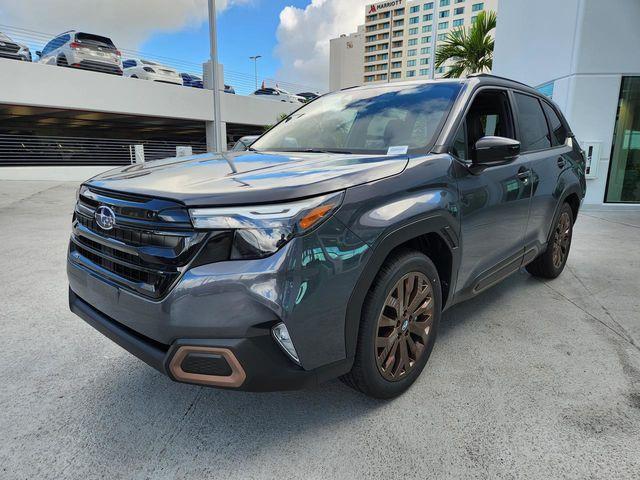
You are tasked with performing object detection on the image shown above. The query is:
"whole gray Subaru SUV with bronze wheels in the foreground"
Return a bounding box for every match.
[68,74,585,398]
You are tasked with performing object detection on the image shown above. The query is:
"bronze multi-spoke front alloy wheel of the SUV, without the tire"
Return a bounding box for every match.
[375,272,434,381]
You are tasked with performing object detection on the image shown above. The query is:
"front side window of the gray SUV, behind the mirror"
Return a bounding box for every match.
[451,90,515,161]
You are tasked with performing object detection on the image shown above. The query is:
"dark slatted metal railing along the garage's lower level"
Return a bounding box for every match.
[0,134,207,167]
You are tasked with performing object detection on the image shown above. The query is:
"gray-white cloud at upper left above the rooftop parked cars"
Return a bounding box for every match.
[0,0,252,49]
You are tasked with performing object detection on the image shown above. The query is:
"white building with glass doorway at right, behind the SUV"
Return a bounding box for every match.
[493,0,640,205]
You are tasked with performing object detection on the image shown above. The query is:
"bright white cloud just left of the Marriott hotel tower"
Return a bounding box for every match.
[275,0,371,87]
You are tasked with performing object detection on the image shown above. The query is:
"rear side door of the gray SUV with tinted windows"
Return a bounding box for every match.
[513,91,571,259]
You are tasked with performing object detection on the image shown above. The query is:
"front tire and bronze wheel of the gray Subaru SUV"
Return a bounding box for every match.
[342,250,442,399]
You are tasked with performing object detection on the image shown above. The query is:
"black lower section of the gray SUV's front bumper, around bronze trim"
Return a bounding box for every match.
[69,289,351,391]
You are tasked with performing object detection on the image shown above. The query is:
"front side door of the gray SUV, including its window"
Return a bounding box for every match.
[453,89,531,299]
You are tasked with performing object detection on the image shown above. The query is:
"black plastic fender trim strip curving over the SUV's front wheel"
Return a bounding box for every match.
[344,214,460,359]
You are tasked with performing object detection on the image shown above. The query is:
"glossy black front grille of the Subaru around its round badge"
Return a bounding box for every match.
[69,188,230,298]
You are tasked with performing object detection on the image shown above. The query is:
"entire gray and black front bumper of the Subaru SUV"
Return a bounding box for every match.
[67,219,369,390]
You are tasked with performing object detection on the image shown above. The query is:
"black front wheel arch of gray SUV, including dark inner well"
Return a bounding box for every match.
[345,215,460,358]
